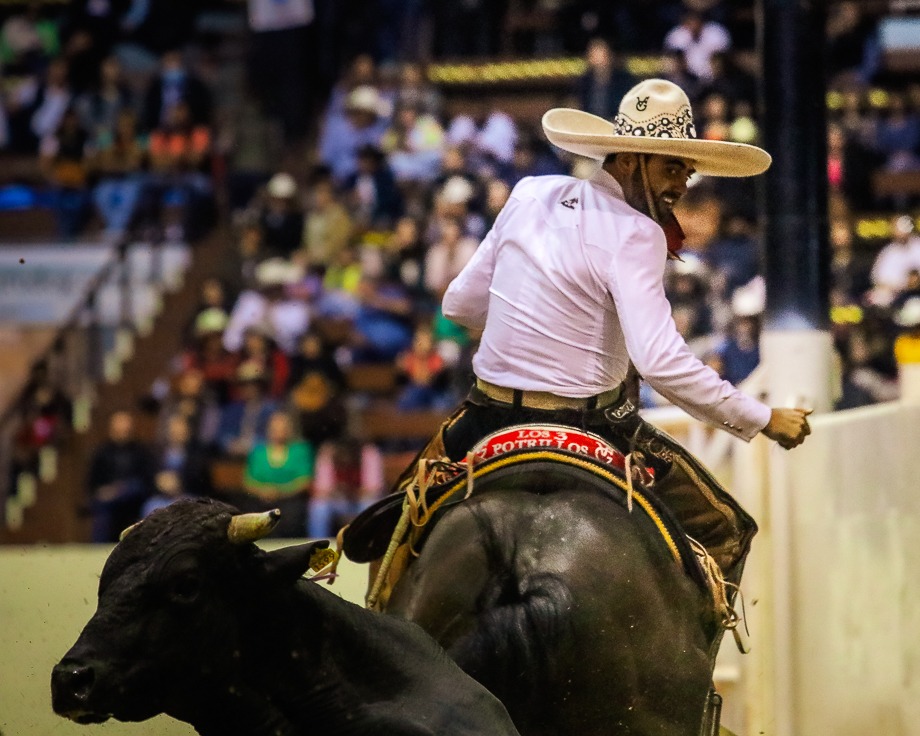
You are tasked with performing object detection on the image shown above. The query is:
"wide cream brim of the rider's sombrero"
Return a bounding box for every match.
[543,107,773,176]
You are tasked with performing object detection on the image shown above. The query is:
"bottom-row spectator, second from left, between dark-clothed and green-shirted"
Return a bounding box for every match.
[141,414,211,518]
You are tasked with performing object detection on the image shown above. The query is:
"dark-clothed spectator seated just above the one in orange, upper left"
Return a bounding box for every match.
[143,49,212,131]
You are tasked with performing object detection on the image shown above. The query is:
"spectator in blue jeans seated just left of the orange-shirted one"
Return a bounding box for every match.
[93,108,150,239]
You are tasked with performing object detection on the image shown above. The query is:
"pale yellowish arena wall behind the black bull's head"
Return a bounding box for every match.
[0,541,367,736]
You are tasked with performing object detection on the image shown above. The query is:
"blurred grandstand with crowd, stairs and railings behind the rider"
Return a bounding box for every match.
[0,0,920,734]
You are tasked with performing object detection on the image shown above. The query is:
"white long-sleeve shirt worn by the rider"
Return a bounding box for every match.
[443,169,770,440]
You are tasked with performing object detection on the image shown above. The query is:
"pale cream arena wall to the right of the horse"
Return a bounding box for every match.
[723,403,920,736]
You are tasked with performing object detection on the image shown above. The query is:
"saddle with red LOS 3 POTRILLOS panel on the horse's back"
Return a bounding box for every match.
[342,424,709,605]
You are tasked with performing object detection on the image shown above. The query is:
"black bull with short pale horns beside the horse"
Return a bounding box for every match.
[51,501,517,736]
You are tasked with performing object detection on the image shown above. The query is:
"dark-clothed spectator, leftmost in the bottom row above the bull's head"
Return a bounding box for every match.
[87,411,153,543]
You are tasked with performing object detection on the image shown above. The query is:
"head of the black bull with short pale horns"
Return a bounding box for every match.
[51,500,328,723]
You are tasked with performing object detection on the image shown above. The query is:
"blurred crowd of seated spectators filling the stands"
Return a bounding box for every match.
[0,0,920,541]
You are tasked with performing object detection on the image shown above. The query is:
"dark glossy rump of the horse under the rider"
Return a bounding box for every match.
[345,469,723,736]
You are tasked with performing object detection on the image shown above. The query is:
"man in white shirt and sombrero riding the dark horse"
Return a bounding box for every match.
[392,79,810,581]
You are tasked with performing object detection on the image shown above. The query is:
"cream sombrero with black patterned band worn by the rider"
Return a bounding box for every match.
[543,79,772,176]
